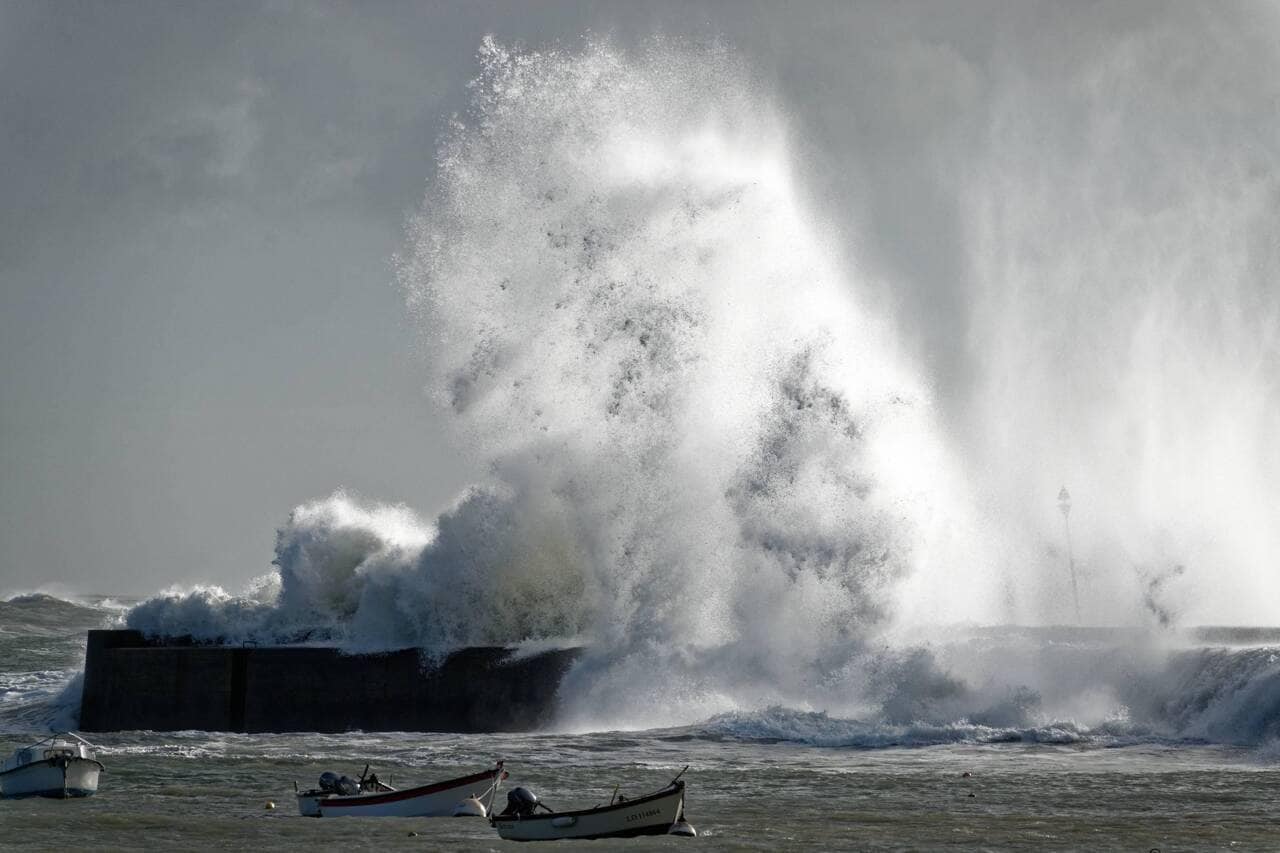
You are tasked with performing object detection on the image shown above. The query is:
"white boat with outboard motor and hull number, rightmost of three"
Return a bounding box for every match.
[489,771,696,841]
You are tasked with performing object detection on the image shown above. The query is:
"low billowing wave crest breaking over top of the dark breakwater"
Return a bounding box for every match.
[127,488,582,653]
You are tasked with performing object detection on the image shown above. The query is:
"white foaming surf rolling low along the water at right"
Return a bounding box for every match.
[692,635,1280,752]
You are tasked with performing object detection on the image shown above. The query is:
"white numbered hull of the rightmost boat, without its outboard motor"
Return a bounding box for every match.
[493,783,685,841]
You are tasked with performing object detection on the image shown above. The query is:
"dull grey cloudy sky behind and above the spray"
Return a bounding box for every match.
[0,0,1277,604]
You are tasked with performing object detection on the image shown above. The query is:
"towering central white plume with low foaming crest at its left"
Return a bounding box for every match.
[129,41,967,725]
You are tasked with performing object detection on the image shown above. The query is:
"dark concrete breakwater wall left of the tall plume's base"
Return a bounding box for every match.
[79,630,580,733]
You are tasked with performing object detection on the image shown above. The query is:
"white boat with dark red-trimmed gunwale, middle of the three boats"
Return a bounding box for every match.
[298,761,507,817]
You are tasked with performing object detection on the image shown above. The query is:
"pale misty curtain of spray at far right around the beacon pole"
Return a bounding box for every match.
[957,6,1280,624]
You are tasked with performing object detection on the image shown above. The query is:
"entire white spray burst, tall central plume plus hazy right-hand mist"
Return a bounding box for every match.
[128,28,1280,740]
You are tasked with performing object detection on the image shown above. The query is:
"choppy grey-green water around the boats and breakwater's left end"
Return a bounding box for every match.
[0,596,1280,850]
